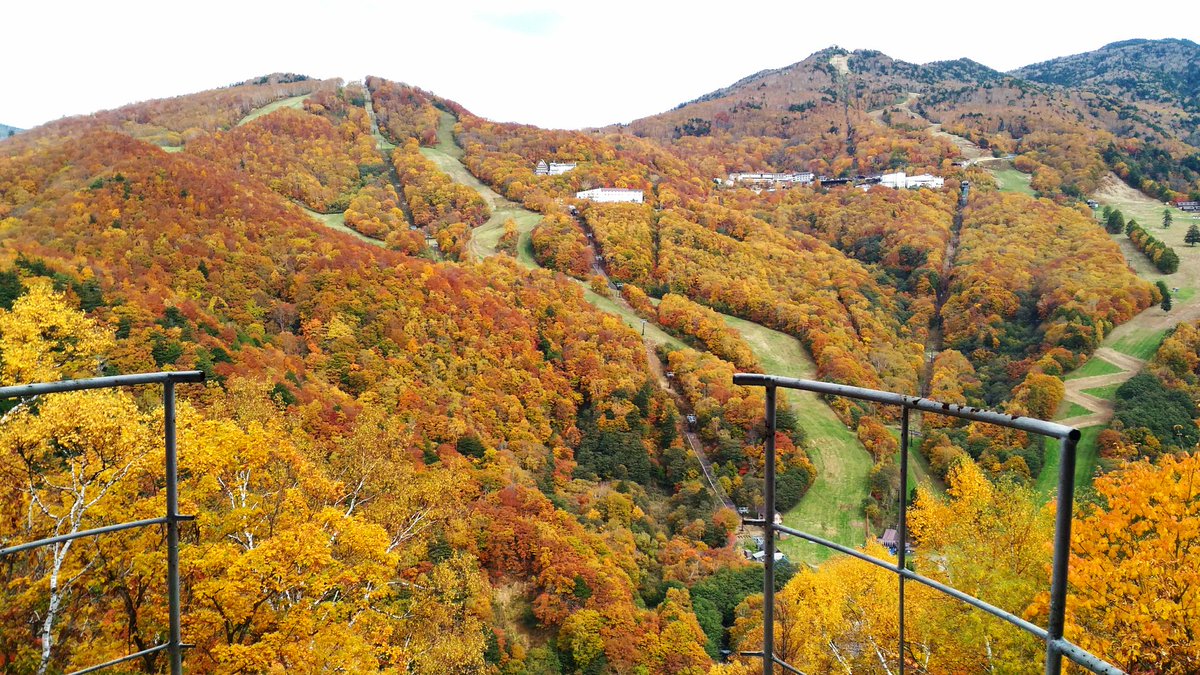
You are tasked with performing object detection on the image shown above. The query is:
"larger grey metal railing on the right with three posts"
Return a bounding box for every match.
[733,372,1122,675]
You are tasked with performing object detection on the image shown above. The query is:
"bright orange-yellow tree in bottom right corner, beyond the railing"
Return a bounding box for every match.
[1030,453,1200,674]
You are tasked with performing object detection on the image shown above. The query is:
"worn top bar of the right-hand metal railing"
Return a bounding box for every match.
[733,372,1079,440]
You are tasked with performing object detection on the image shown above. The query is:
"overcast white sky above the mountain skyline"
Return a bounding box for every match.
[0,0,1200,127]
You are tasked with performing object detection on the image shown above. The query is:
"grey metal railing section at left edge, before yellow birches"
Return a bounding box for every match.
[0,370,204,675]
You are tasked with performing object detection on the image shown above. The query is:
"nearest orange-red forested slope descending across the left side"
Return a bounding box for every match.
[0,86,729,673]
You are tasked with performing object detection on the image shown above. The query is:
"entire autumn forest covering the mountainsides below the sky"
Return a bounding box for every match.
[0,41,1200,675]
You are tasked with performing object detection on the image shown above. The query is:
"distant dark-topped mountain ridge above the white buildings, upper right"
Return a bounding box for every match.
[628,40,1200,199]
